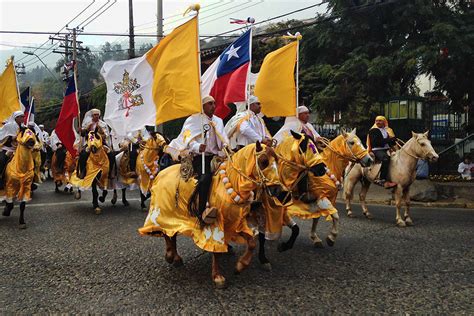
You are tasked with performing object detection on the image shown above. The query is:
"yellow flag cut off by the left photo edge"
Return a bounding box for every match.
[0,61,22,123]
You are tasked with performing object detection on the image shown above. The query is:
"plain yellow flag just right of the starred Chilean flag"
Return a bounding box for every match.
[255,41,298,117]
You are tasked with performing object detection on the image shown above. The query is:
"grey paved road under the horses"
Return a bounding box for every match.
[0,183,474,314]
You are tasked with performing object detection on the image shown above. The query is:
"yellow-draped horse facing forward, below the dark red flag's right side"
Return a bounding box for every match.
[71,129,109,215]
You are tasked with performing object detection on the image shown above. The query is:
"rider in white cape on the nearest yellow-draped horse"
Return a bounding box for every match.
[165,96,229,224]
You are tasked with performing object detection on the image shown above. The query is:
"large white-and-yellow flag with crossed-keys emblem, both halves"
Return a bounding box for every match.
[101,17,201,136]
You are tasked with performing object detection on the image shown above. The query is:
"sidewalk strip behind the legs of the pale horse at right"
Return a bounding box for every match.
[337,183,474,209]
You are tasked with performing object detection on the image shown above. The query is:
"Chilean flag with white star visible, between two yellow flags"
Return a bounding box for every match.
[201,29,252,119]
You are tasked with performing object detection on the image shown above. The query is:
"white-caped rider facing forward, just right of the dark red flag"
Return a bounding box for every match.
[77,109,115,179]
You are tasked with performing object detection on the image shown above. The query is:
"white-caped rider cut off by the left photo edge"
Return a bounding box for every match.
[0,111,25,189]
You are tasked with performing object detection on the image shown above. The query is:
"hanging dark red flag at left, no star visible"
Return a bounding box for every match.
[55,76,79,157]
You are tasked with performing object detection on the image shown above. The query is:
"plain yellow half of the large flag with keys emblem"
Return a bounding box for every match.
[146,17,201,125]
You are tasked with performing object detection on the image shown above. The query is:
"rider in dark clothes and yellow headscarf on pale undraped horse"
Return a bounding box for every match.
[367,115,397,189]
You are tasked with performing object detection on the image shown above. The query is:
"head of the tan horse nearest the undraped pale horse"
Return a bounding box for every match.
[330,128,373,167]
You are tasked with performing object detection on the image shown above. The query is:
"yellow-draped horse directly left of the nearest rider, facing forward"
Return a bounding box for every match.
[135,133,166,210]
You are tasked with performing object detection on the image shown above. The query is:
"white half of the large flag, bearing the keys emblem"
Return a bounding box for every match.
[100,55,156,136]
